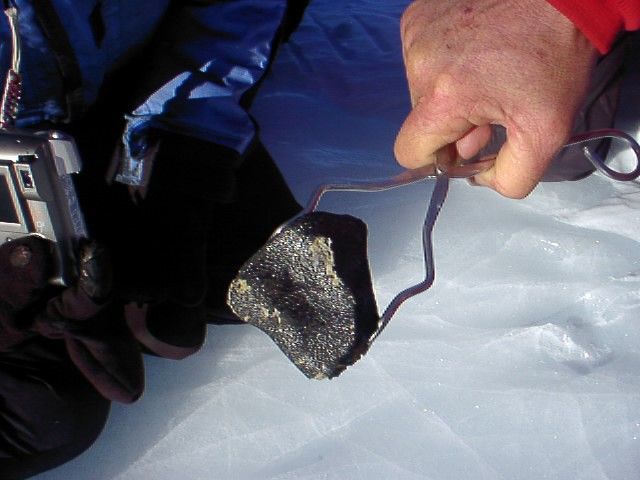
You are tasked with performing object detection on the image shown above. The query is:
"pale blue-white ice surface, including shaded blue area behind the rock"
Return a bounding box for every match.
[37,0,640,480]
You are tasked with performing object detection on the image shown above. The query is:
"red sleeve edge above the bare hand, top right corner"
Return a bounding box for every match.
[547,0,640,53]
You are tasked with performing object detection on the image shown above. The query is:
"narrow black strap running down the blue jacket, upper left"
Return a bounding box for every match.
[32,0,85,122]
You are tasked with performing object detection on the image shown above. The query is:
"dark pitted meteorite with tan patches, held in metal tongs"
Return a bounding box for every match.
[228,212,379,379]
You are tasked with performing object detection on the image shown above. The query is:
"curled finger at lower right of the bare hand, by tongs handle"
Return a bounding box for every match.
[473,129,563,199]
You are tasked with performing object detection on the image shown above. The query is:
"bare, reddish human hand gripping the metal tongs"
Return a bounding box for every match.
[395,0,597,198]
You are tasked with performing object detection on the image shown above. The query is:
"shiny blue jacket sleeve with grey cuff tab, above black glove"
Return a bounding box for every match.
[116,0,287,185]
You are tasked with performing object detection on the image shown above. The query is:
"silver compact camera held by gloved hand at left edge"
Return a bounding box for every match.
[0,129,87,285]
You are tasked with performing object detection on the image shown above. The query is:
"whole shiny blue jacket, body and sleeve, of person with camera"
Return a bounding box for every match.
[0,0,287,185]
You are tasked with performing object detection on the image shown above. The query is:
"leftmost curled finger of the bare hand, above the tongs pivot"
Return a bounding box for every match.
[394,100,475,168]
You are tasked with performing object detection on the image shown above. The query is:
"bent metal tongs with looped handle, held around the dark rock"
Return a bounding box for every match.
[300,129,640,345]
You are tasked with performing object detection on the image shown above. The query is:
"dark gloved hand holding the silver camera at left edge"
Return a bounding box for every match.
[0,236,144,403]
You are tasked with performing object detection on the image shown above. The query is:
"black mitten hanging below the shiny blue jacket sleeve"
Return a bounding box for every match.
[108,133,239,359]
